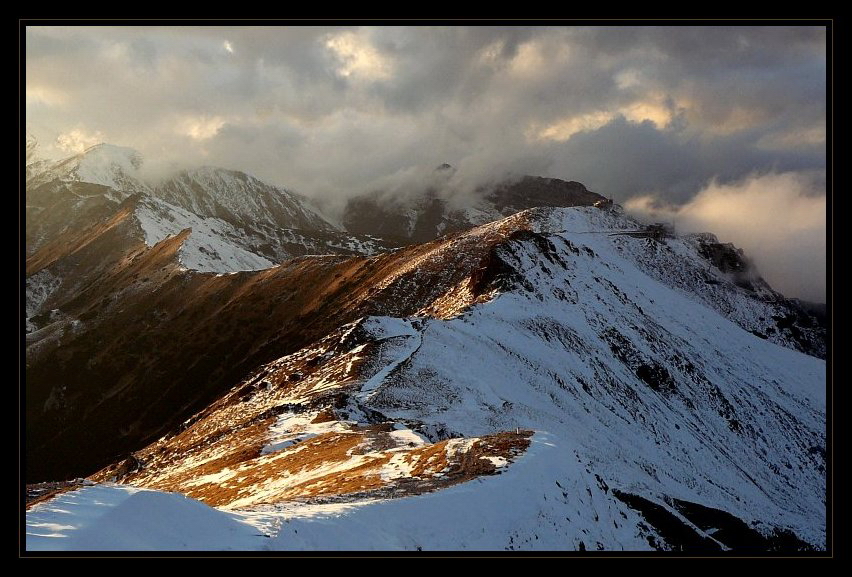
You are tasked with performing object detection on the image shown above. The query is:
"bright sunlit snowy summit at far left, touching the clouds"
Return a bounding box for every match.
[28,144,150,196]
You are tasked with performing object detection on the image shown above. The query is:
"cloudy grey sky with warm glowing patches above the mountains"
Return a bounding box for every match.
[25,25,826,301]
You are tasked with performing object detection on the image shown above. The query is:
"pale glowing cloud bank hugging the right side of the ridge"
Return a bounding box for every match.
[625,172,826,302]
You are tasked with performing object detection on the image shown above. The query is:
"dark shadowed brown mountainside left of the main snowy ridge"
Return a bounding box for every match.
[26,209,525,482]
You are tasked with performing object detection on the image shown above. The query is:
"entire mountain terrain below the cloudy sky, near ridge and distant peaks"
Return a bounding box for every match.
[25,137,827,553]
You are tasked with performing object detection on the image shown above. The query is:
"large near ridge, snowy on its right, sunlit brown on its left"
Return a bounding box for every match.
[28,208,826,553]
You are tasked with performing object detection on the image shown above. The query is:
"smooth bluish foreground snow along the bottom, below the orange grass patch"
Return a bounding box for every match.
[27,433,650,551]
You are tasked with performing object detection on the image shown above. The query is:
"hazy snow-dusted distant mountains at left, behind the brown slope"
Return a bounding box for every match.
[27,142,390,273]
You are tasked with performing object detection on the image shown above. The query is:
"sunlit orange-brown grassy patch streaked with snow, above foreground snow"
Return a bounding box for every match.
[95,413,532,508]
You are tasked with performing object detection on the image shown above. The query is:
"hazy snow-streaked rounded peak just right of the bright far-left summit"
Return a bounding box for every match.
[153,166,333,230]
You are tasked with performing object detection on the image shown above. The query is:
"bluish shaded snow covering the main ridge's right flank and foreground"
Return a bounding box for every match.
[27,209,826,550]
